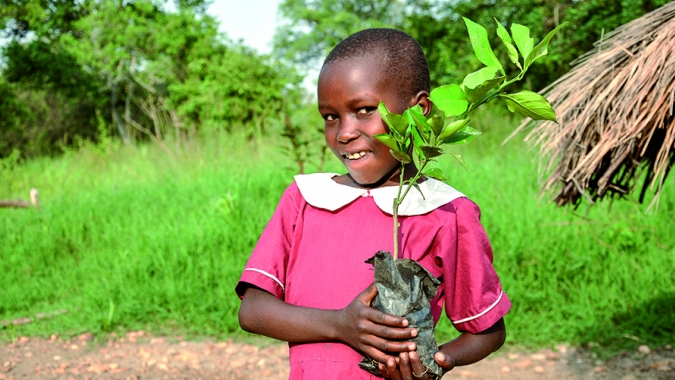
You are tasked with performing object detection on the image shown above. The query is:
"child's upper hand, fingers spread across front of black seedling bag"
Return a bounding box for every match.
[337,284,417,363]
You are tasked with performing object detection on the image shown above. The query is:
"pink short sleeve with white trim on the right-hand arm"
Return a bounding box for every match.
[441,198,511,334]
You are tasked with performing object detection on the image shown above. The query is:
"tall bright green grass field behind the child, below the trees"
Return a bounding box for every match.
[0,111,675,354]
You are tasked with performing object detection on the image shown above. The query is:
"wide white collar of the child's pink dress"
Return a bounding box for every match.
[295,173,465,216]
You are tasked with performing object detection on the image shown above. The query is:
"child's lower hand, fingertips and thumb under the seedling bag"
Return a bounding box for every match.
[379,351,454,380]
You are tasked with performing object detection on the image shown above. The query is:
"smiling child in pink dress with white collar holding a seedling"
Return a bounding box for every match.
[236,29,511,379]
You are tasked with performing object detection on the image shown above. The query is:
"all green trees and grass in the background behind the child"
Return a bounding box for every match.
[0,0,675,354]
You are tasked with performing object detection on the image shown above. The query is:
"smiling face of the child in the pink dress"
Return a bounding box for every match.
[317,57,415,185]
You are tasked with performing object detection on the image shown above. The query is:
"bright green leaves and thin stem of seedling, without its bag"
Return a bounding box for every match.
[373,18,564,259]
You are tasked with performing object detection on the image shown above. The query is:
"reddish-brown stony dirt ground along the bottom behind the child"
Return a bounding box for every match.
[0,331,675,380]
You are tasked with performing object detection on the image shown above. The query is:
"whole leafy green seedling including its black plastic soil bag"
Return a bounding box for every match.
[360,18,565,378]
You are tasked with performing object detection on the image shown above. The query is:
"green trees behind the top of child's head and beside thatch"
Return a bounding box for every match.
[275,0,668,90]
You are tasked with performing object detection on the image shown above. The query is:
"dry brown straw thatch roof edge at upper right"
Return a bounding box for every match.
[514,2,675,211]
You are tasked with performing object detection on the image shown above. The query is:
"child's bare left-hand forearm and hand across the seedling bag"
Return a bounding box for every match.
[239,284,417,362]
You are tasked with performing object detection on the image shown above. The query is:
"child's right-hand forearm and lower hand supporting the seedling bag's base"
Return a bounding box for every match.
[380,318,506,380]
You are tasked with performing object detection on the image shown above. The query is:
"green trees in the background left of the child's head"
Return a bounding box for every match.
[0,0,300,157]
